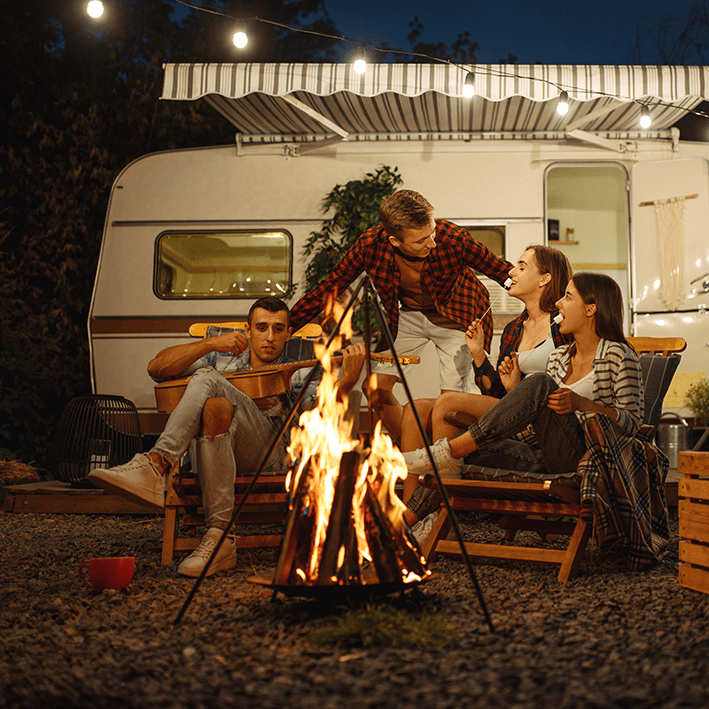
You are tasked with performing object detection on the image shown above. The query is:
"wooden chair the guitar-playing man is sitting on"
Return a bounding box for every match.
[162,322,322,565]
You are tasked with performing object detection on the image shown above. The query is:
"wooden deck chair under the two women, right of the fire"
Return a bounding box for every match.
[422,338,686,582]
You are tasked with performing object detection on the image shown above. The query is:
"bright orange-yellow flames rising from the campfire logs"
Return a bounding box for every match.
[286,296,430,584]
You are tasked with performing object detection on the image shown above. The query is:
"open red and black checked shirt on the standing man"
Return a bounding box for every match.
[291,219,513,349]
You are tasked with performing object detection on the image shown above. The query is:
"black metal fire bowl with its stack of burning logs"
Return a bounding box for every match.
[249,436,432,597]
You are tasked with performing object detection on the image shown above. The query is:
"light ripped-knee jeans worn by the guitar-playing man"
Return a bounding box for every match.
[151,369,287,529]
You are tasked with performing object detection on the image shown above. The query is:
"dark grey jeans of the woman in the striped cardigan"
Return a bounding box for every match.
[465,373,586,475]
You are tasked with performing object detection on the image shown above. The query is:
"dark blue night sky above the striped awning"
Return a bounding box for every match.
[326,0,692,64]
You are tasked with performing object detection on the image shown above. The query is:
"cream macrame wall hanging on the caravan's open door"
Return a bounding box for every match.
[655,197,684,310]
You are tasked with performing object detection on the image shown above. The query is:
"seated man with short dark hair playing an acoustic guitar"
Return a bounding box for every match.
[88,296,366,577]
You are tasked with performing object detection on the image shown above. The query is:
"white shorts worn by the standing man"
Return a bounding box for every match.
[372,310,477,392]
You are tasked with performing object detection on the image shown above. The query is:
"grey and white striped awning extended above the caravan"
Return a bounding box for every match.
[162,64,709,143]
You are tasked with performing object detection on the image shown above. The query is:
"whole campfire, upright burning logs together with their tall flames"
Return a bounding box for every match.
[272,302,431,587]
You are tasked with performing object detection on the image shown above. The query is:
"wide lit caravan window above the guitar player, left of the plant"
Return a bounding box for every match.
[155,231,293,299]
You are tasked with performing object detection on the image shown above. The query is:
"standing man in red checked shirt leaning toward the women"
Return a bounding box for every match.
[291,190,513,440]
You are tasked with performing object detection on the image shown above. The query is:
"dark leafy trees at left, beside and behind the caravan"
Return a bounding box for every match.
[0,0,336,465]
